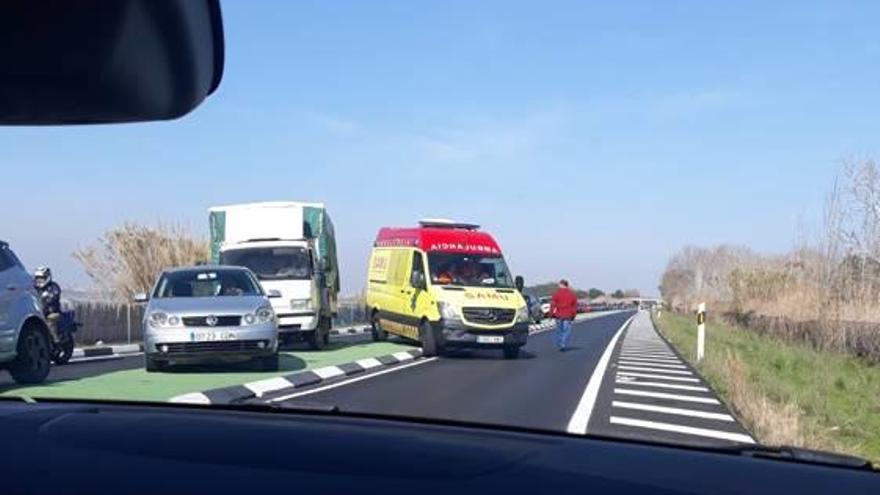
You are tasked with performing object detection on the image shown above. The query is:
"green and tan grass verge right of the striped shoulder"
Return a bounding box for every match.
[654,310,880,464]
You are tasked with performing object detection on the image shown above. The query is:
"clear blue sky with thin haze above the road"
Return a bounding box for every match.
[0,0,880,293]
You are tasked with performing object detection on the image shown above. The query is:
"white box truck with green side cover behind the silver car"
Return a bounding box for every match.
[208,201,339,349]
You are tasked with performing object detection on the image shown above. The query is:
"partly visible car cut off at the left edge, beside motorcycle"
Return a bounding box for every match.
[0,241,51,384]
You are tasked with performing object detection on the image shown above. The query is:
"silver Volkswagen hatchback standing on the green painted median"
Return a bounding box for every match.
[135,266,278,371]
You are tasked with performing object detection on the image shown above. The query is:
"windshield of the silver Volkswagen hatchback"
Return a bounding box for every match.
[153,270,262,299]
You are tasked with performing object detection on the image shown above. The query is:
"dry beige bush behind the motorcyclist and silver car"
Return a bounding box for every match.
[73,223,209,302]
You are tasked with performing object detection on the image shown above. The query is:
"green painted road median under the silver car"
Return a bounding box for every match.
[0,342,413,401]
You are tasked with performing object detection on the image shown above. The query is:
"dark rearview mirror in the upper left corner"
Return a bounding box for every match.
[0,0,224,125]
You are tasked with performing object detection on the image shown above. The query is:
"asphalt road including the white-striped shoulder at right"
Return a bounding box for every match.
[259,312,752,446]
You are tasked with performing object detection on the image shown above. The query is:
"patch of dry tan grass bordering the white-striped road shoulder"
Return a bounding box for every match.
[724,353,805,446]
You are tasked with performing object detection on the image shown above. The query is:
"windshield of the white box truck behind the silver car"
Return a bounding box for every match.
[220,247,312,280]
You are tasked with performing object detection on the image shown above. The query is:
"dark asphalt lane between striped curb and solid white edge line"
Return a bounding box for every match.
[267,312,632,431]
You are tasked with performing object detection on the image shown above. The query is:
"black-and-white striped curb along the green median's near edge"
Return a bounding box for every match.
[169,349,422,405]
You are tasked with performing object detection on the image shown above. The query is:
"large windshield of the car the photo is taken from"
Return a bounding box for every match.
[6,0,880,468]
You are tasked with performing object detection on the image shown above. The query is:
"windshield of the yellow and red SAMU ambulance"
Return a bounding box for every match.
[428,253,513,288]
